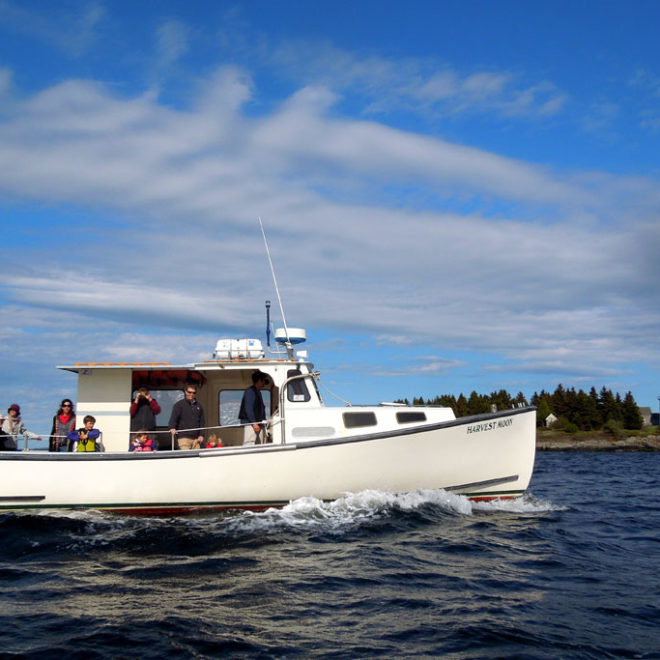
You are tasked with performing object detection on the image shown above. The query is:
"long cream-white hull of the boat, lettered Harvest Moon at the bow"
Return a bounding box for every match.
[0,408,536,514]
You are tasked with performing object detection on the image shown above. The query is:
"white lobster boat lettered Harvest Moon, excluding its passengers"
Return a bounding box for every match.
[0,329,536,514]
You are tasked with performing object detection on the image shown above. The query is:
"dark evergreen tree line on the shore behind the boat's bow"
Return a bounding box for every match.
[399,384,643,432]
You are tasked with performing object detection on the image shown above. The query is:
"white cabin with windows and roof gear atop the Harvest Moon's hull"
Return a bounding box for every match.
[58,330,455,452]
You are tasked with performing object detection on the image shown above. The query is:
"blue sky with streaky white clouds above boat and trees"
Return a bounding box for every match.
[0,0,660,433]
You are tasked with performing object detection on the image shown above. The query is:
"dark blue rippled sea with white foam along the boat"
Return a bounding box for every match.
[0,452,660,659]
